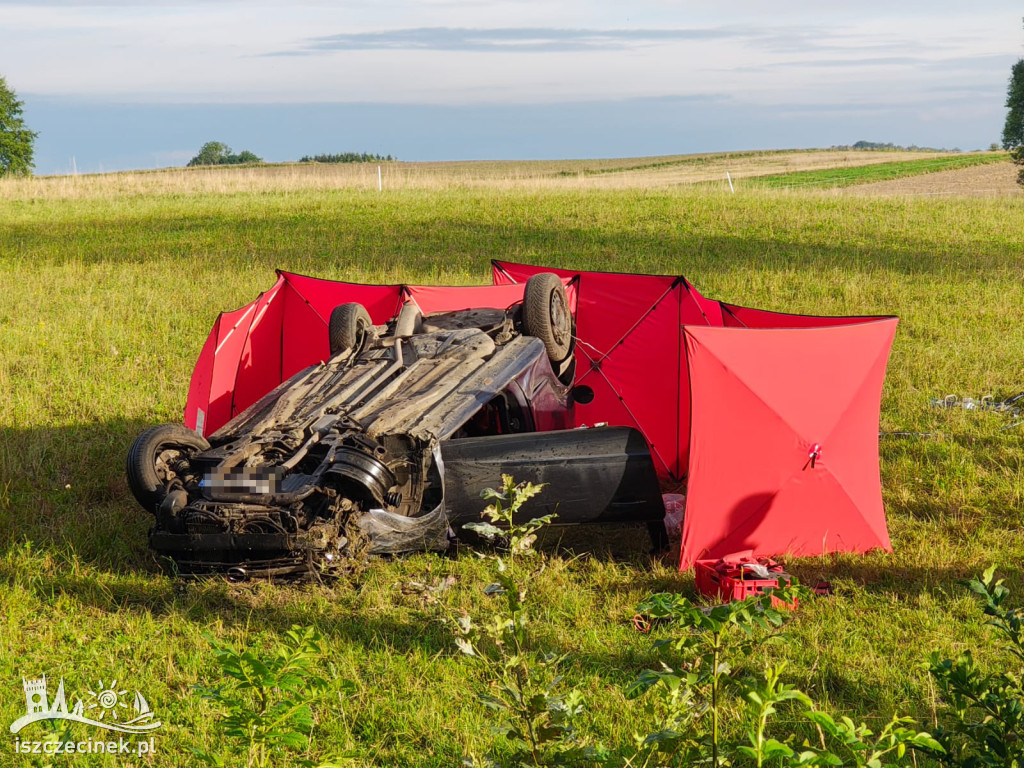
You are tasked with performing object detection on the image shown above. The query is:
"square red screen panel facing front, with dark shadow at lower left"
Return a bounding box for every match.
[680,318,896,568]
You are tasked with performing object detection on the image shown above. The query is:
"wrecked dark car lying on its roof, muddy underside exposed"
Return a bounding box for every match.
[127,272,664,580]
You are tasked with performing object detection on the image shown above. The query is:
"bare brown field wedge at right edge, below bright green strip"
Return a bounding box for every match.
[840,156,1024,198]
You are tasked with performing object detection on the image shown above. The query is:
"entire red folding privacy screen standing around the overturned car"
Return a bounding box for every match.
[185,261,896,567]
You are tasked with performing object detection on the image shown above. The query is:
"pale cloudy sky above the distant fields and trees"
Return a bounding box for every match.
[0,0,1024,174]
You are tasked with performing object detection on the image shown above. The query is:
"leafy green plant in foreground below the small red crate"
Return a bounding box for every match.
[627,584,941,768]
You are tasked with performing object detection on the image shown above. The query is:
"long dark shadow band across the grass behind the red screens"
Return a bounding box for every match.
[5,193,1017,280]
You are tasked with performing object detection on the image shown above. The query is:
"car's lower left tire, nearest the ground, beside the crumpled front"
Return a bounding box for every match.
[125,424,210,514]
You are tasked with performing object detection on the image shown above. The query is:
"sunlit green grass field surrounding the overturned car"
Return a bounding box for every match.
[0,153,1024,766]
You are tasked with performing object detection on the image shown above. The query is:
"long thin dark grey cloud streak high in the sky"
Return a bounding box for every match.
[276,27,757,55]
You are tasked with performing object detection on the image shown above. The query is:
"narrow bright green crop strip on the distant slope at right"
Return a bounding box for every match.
[743,153,1007,189]
